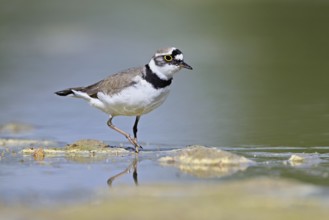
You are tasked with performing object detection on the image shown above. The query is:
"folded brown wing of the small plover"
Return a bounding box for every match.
[78,67,143,98]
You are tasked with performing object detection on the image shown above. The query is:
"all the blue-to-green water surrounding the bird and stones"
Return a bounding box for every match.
[0,0,329,212]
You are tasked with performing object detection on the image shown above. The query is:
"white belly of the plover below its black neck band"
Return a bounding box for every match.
[89,80,169,116]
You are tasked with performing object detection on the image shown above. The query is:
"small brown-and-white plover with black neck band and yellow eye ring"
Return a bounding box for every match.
[55,47,193,153]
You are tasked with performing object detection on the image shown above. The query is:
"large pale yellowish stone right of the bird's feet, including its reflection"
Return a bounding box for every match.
[159,145,253,177]
